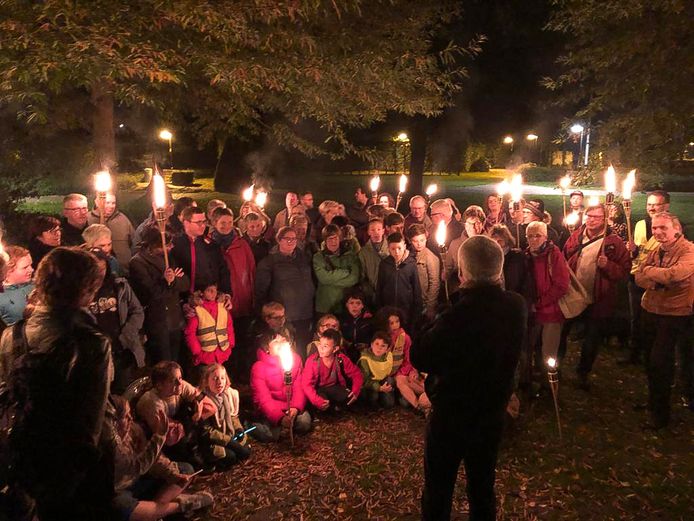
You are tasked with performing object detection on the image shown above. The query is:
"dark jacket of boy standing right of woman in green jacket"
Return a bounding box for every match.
[376,254,423,324]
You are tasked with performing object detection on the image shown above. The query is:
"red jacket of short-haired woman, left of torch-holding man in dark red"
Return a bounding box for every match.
[526,241,569,324]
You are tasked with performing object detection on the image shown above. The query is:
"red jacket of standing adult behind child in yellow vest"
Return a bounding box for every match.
[222,235,255,317]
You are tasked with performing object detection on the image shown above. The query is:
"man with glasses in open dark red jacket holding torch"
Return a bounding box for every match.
[559,204,630,391]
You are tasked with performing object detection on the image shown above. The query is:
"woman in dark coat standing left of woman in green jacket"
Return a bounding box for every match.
[255,226,315,356]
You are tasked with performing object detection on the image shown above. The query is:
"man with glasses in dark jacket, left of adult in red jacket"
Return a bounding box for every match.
[171,206,231,293]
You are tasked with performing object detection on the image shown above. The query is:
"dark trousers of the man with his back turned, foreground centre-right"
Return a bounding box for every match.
[422,407,503,521]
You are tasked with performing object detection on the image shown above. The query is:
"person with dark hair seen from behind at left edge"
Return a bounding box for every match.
[0,247,114,519]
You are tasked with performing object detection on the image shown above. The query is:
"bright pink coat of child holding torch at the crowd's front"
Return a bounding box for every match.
[251,349,306,425]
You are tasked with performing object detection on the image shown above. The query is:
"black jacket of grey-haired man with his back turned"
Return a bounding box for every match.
[410,285,527,429]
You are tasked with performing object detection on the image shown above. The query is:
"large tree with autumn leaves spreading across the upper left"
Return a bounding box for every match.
[0,0,474,175]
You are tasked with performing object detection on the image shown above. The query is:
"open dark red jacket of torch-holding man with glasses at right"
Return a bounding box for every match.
[564,225,631,318]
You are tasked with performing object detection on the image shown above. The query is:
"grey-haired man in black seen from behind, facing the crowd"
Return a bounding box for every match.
[410,236,527,520]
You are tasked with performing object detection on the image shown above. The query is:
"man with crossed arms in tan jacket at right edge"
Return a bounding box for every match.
[635,212,694,429]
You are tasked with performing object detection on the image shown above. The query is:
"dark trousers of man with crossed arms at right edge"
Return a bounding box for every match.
[641,310,691,425]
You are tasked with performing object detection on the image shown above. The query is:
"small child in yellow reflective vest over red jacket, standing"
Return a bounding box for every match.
[185,283,234,374]
